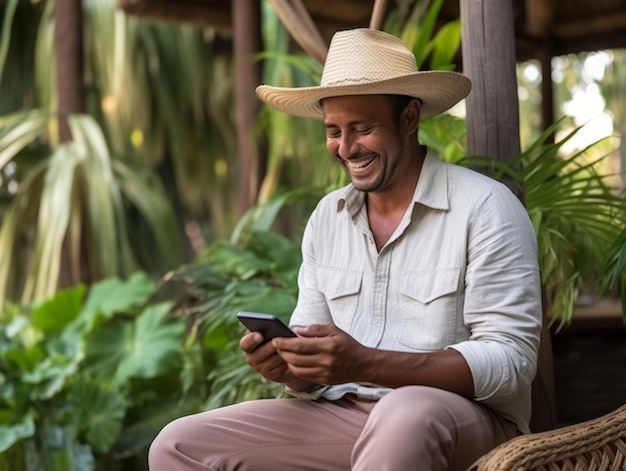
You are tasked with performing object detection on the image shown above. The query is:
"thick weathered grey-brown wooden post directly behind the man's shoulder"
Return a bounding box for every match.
[460,0,556,431]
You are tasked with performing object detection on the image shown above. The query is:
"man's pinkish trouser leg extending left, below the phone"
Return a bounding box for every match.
[149,399,371,471]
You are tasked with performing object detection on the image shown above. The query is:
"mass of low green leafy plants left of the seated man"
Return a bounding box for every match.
[0,183,321,471]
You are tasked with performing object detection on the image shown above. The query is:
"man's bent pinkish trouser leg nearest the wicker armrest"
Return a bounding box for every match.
[353,386,515,471]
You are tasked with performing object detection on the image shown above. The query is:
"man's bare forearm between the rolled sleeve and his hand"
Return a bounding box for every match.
[357,349,474,398]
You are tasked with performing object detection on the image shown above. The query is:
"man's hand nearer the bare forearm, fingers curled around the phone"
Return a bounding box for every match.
[271,324,369,385]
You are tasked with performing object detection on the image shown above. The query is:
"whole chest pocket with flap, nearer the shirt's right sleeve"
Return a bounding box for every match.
[398,268,462,350]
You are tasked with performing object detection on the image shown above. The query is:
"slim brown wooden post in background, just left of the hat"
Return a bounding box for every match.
[232,0,266,215]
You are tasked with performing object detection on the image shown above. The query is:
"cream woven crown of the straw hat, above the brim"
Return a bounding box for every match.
[320,28,418,86]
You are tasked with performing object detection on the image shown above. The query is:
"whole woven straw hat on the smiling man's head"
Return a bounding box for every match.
[256,28,471,119]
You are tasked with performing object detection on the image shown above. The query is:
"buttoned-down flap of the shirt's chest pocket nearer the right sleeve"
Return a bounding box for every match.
[400,268,460,304]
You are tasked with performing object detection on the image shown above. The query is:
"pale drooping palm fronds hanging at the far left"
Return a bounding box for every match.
[0,110,180,306]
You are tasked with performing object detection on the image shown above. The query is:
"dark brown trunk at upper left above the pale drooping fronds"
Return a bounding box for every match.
[54,0,85,142]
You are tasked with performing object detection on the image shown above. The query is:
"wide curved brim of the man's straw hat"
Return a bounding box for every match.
[256,70,472,119]
